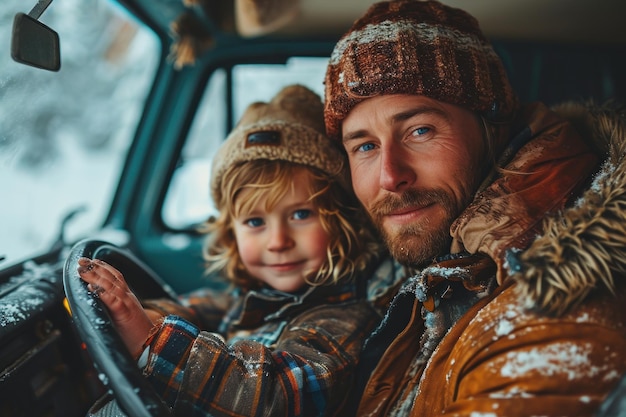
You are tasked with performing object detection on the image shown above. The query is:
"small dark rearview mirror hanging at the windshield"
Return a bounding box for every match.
[11,13,61,71]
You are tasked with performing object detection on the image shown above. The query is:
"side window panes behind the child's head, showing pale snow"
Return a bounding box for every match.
[162,57,328,230]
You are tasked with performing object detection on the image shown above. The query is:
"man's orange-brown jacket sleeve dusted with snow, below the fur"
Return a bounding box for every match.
[404,282,626,417]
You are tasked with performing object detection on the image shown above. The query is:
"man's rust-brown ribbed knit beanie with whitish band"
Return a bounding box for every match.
[324,0,517,139]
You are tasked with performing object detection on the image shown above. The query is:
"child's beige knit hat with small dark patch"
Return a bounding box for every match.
[211,85,350,209]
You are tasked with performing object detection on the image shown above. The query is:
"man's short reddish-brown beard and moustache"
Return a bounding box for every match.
[370,189,460,267]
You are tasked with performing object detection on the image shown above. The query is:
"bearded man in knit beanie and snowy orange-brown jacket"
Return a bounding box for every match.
[325,0,626,416]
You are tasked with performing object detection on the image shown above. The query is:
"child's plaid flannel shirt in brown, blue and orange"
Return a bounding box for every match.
[139,284,380,416]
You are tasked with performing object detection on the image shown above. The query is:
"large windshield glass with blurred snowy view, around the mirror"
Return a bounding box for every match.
[0,0,159,265]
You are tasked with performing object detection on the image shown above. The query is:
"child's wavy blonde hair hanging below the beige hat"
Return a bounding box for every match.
[204,159,381,288]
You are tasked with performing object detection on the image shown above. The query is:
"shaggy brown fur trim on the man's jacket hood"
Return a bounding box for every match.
[508,103,626,315]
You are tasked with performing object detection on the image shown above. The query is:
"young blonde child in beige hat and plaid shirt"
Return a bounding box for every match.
[79,85,381,416]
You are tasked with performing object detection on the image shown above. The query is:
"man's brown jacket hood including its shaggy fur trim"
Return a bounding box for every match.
[451,102,626,315]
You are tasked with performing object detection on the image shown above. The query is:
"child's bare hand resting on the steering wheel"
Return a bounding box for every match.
[78,258,153,356]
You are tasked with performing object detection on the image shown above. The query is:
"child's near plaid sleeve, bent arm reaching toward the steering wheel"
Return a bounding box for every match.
[144,302,379,416]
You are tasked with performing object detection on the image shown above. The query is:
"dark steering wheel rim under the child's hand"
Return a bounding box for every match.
[63,240,173,417]
